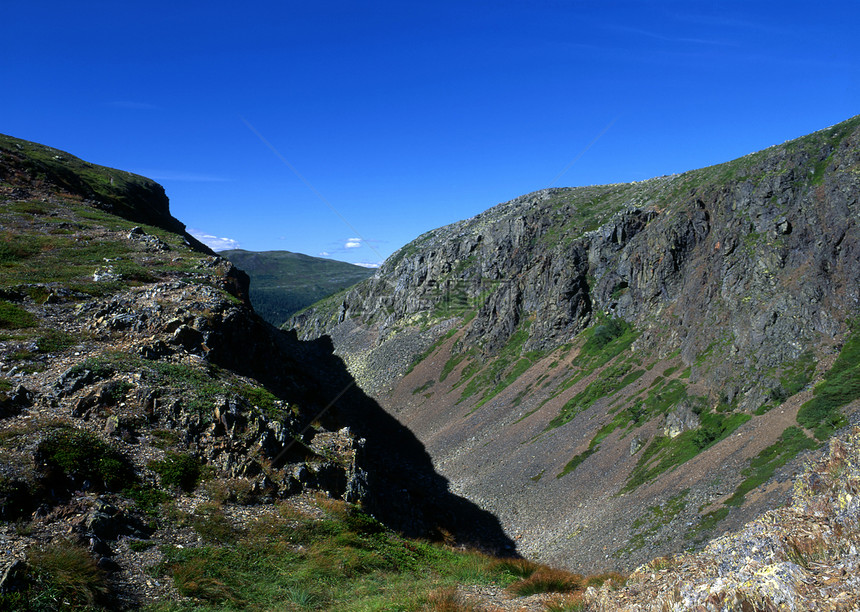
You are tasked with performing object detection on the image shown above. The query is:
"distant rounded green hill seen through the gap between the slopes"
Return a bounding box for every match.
[221,250,373,326]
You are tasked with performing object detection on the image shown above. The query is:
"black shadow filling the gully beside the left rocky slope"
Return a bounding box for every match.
[201,306,516,556]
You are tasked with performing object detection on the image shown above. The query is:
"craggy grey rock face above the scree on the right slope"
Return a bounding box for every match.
[292,118,860,409]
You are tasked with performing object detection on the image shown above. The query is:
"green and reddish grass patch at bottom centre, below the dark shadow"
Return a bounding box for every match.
[154,502,520,611]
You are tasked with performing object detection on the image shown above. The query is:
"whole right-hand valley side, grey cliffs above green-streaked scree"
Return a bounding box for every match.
[291,117,860,571]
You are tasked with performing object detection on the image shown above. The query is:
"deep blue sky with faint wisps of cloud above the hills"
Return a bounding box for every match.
[0,0,860,263]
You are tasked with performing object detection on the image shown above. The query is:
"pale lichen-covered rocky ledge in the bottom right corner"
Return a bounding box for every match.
[584,427,860,612]
